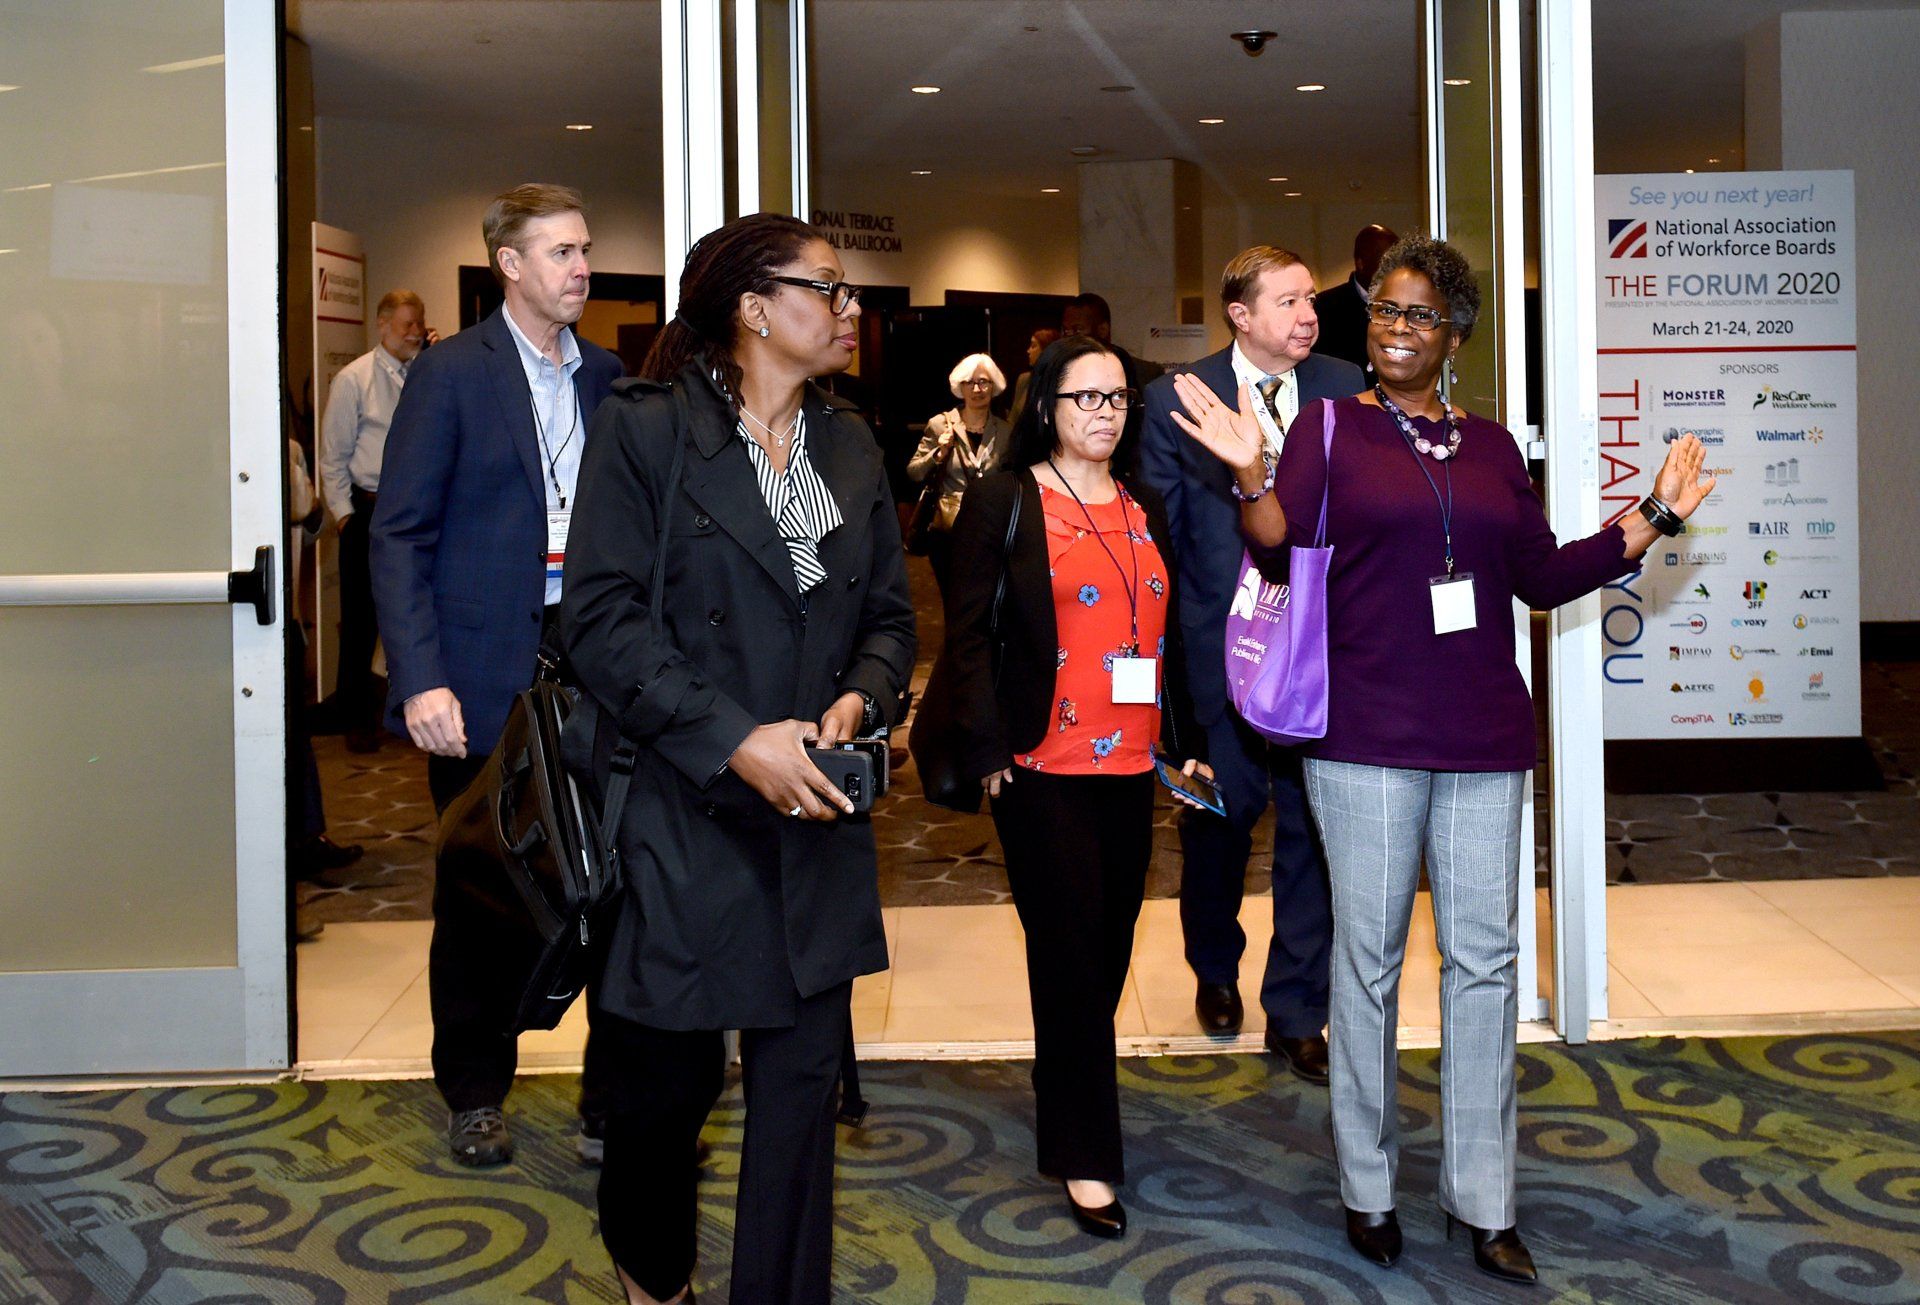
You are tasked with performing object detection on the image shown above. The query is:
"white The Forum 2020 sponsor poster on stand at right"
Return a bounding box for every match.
[1596,171,1860,741]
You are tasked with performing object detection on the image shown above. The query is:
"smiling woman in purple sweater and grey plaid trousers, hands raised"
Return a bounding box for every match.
[1173,236,1713,1282]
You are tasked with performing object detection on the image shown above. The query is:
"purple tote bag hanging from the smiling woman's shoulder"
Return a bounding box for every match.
[1227,401,1332,743]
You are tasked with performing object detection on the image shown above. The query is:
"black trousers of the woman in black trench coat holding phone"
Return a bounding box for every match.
[593,983,852,1305]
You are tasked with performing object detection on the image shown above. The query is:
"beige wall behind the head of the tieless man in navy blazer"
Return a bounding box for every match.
[315,117,662,334]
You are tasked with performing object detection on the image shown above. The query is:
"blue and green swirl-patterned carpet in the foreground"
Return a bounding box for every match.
[0,1034,1920,1305]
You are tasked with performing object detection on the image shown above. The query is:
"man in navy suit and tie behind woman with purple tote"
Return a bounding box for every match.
[1140,246,1363,1084]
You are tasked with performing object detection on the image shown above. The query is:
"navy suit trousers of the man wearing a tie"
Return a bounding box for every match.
[1181,708,1332,1038]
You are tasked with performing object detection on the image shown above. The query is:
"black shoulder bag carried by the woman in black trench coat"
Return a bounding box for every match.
[436,390,685,1032]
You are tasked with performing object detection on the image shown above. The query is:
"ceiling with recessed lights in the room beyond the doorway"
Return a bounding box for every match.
[288,0,1920,200]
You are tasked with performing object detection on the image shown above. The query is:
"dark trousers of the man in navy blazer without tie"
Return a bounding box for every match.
[426,667,611,1130]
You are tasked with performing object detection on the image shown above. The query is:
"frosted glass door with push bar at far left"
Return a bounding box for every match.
[0,0,288,1077]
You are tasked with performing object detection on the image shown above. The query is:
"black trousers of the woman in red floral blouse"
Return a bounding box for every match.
[993,770,1154,1182]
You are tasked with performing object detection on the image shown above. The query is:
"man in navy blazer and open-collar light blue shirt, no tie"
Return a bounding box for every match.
[371,184,620,1165]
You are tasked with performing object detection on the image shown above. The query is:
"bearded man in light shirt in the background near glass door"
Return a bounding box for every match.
[319,290,438,752]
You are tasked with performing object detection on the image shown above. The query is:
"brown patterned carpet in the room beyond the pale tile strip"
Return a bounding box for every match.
[300,558,1920,921]
